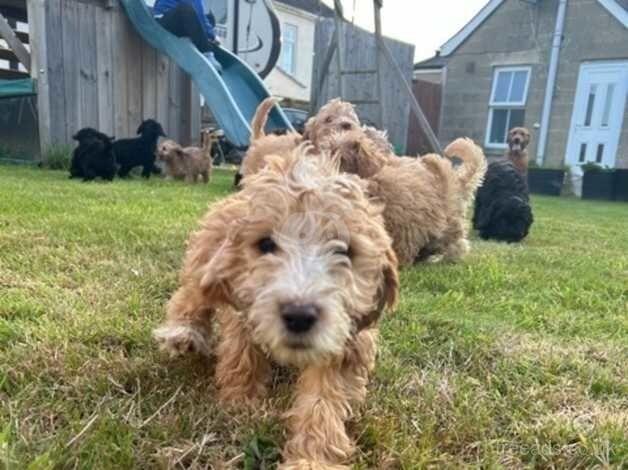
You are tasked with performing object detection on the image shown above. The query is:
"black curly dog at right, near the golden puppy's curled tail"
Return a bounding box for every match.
[473,161,534,243]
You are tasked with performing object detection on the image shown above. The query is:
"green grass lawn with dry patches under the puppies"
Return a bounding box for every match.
[0,166,628,469]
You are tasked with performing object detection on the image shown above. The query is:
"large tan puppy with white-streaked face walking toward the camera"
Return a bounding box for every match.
[155,146,398,470]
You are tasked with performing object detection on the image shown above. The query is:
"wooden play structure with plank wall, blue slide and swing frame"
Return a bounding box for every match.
[0,0,437,156]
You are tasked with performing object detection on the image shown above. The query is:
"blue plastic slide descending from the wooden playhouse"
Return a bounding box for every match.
[120,0,292,147]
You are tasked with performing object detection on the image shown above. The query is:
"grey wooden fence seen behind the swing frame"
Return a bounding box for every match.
[312,18,414,151]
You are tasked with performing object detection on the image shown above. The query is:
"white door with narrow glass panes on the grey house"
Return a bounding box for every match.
[567,62,628,167]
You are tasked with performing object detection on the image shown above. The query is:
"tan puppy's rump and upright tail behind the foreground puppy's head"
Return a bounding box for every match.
[236,97,303,186]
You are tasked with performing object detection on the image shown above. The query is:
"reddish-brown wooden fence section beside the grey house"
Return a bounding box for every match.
[407,79,442,155]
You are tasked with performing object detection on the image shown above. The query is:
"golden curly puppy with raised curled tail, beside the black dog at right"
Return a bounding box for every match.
[368,139,486,265]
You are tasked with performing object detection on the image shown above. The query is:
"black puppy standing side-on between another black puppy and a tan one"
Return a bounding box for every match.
[113,119,166,178]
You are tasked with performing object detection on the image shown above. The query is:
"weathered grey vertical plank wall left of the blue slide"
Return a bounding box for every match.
[29,0,200,151]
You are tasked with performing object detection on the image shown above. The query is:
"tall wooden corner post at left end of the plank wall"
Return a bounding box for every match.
[26,0,52,161]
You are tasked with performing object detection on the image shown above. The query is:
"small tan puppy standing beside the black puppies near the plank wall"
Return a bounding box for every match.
[157,135,212,183]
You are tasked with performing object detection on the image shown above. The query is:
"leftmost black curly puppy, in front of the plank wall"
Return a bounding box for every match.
[70,127,116,181]
